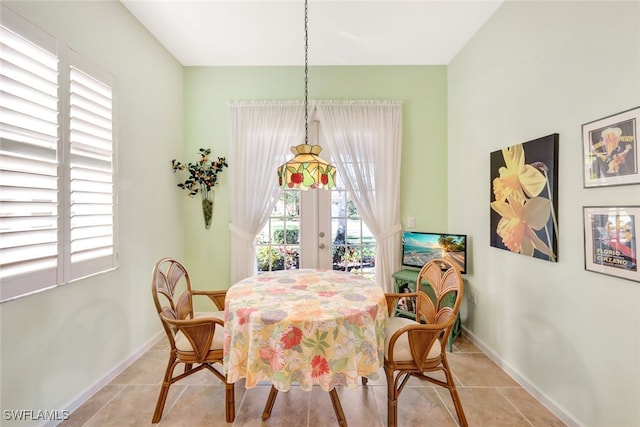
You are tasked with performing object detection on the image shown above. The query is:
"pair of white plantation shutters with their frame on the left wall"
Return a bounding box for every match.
[0,5,116,302]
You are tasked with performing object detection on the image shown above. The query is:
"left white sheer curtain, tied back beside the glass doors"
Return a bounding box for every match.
[229,101,304,283]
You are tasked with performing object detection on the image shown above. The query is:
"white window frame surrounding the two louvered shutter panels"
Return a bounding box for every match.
[0,5,118,303]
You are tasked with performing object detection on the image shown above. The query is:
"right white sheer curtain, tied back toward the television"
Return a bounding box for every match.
[316,101,402,292]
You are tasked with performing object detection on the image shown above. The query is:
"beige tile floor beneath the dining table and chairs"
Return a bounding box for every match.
[59,336,565,427]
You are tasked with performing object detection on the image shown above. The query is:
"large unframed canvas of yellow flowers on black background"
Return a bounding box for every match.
[489,133,559,262]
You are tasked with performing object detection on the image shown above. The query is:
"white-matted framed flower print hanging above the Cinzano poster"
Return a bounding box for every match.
[582,107,640,188]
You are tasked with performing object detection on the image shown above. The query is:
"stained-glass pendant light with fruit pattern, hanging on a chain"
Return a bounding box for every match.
[278,0,336,190]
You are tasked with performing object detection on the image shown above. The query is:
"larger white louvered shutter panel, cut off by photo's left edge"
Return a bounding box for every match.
[0,15,59,300]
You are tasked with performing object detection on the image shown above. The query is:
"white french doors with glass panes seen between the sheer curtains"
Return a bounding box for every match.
[256,122,375,279]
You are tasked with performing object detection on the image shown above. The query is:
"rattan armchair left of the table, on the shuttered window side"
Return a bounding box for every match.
[151,258,235,423]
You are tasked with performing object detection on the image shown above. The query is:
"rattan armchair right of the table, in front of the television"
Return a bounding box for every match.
[384,259,468,427]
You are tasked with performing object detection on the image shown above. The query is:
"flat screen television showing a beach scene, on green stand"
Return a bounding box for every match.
[402,231,467,274]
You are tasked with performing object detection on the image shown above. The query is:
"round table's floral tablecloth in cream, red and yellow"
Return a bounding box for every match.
[224,269,387,391]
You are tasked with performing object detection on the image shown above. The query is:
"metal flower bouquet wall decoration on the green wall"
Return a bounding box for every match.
[171,148,229,229]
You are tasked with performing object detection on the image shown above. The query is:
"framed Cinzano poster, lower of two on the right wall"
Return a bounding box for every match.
[583,206,640,282]
